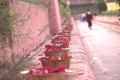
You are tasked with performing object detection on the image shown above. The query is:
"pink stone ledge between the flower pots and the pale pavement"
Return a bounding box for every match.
[66,18,96,80]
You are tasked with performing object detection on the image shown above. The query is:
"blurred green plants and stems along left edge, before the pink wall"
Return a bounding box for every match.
[0,0,49,80]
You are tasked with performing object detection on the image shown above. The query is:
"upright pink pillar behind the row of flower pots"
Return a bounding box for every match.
[49,0,61,34]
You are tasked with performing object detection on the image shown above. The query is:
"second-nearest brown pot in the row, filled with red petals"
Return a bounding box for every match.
[39,55,71,68]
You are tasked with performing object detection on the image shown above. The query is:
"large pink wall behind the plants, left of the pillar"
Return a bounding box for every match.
[10,1,50,54]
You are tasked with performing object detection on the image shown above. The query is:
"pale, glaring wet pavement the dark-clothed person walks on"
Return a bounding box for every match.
[75,20,120,80]
